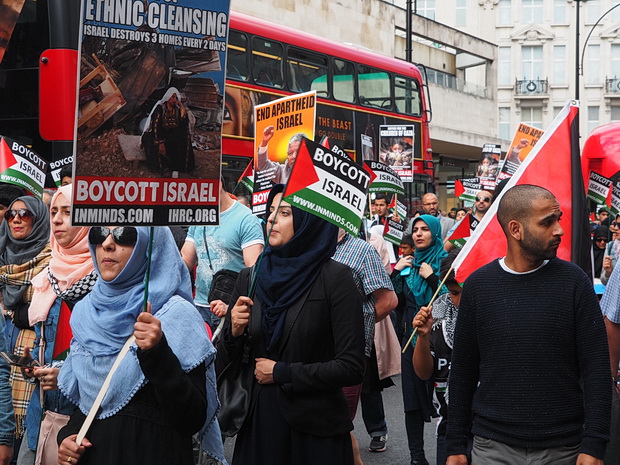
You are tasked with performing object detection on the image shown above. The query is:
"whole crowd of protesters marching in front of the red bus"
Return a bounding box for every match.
[0,177,620,465]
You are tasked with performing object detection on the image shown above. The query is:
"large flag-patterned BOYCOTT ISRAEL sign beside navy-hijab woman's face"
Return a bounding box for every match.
[283,138,370,235]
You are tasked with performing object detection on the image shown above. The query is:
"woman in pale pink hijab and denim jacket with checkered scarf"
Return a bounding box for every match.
[17,184,97,465]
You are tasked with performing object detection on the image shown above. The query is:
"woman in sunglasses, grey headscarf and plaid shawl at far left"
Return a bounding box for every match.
[0,196,51,454]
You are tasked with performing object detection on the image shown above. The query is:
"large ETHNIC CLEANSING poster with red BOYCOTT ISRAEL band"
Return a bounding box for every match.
[72,0,229,225]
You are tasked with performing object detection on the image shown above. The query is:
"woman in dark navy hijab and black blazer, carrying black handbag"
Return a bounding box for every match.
[216,185,364,465]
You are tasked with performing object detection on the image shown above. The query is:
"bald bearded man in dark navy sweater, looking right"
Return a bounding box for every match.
[446,185,612,465]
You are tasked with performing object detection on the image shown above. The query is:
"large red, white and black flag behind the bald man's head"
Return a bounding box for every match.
[453,101,591,282]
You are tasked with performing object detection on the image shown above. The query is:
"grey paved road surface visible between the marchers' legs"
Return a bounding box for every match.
[220,377,436,465]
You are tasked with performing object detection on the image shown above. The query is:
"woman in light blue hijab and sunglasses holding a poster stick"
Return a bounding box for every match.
[53,226,224,465]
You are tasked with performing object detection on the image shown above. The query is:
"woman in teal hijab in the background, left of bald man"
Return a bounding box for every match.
[394,215,447,465]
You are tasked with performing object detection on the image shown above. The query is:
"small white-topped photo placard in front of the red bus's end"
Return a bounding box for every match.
[379,125,415,182]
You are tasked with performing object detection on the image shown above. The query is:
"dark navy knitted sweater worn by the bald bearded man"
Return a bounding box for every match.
[447,258,612,459]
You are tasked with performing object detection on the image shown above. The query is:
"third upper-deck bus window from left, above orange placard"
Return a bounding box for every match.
[287,47,329,97]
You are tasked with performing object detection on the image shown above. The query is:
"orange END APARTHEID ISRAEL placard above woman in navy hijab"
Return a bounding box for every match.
[252,91,316,215]
